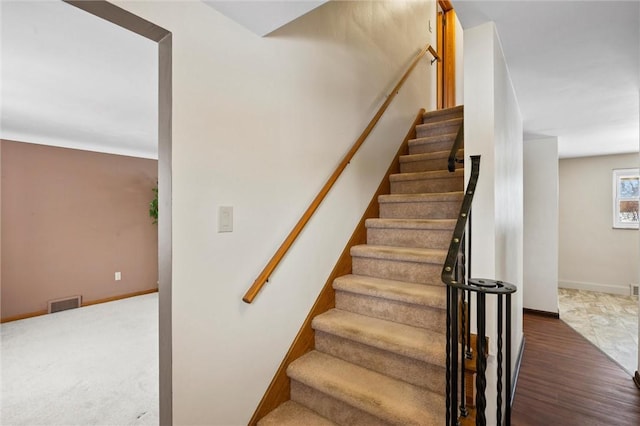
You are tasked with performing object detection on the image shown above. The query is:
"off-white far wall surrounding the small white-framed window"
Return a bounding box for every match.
[558,154,640,295]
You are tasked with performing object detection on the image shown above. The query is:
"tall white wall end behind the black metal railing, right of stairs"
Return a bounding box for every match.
[464,22,523,424]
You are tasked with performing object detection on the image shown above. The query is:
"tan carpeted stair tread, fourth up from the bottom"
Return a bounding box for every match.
[333,274,447,309]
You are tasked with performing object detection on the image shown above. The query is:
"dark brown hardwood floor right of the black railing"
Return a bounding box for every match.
[511,314,640,426]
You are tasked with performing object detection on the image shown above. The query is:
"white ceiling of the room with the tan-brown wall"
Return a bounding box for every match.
[0,1,158,158]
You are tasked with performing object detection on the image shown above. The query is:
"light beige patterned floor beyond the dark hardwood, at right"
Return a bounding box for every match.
[558,288,638,374]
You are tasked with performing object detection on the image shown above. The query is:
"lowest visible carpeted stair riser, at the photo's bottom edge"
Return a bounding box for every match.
[291,380,389,426]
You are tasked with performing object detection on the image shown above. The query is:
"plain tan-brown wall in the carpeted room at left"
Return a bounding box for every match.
[1,141,158,319]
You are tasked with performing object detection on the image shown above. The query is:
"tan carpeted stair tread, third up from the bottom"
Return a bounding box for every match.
[312,309,446,366]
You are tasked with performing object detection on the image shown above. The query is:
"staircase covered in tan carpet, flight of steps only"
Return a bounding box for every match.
[258,107,464,426]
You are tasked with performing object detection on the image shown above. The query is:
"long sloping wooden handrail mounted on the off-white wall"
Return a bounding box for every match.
[242,44,440,303]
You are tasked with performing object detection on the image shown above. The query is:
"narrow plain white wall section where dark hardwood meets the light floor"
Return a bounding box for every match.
[522,137,558,313]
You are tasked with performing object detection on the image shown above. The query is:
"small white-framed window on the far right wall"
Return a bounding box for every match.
[613,169,640,229]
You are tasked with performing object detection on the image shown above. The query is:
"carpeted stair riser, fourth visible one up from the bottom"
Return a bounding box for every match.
[353,256,444,285]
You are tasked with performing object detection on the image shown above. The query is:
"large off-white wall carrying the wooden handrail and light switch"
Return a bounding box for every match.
[119,1,435,425]
